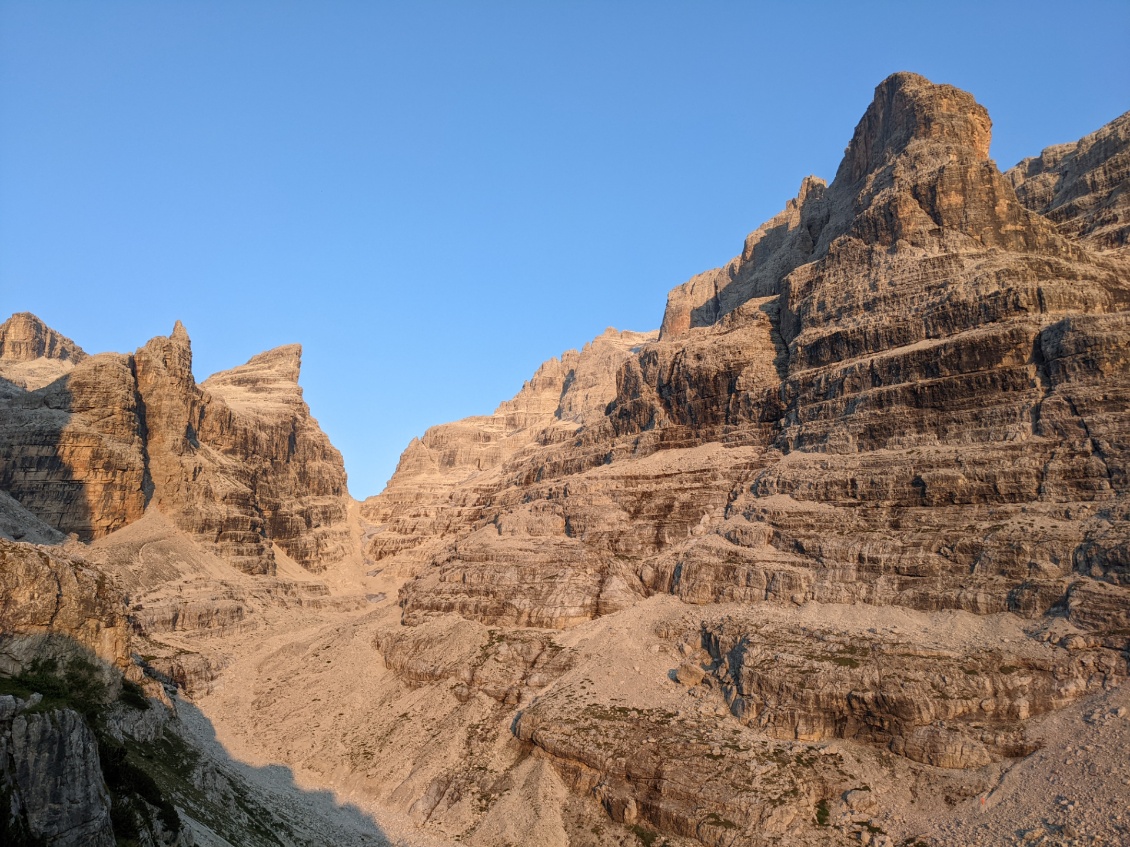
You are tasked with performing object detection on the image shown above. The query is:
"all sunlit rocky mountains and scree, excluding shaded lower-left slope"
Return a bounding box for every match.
[0,73,1130,847]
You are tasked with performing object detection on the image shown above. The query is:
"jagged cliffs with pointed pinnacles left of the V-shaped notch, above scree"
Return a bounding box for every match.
[0,315,348,573]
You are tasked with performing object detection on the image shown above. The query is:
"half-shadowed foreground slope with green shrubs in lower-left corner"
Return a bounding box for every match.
[0,533,397,847]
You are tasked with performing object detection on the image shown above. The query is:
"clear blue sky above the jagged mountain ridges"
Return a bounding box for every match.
[0,0,1130,497]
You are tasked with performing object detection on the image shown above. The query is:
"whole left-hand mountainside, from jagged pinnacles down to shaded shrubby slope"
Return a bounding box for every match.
[0,314,386,847]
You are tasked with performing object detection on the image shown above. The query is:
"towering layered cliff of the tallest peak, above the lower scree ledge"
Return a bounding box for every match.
[366,73,1130,626]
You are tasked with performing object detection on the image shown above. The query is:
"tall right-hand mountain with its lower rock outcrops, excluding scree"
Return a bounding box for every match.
[352,73,1130,845]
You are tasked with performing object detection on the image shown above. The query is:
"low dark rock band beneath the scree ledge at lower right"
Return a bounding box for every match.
[703,617,1127,768]
